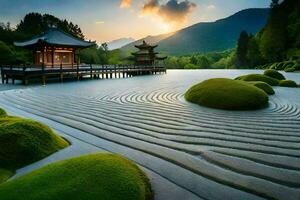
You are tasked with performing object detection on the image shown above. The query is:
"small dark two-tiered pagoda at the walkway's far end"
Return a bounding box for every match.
[132,41,167,65]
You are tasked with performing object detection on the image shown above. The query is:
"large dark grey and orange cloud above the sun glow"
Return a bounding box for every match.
[141,0,196,23]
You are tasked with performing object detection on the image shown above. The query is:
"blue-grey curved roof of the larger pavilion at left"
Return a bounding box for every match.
[14,28,95,48]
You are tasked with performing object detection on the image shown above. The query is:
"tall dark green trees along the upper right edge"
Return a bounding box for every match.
[254,0,300,63]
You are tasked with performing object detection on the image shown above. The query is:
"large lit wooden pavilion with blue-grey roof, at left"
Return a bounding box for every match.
[14,28,95,68]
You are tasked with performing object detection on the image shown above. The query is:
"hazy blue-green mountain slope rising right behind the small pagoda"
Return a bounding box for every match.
[158,8,270,55]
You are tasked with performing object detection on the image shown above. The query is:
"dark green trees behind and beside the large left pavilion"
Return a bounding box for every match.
[0,13,121,64]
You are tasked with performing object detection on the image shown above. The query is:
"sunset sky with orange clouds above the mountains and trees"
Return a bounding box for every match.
[0,0,271,43]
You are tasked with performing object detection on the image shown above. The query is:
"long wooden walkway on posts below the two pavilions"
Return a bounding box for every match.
[0,65,166,85]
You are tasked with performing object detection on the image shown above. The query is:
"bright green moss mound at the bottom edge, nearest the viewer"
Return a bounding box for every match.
[0,154,152,200]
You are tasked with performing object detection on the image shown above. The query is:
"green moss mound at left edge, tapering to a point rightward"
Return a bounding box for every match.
[0,117,68,170]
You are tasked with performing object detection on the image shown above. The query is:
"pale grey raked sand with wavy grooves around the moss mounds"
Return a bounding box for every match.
[0,70,300,200]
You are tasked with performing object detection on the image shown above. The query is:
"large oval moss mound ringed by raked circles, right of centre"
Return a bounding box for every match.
[185,78,269,110]
